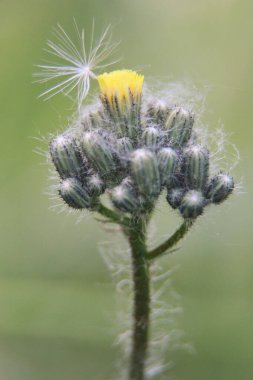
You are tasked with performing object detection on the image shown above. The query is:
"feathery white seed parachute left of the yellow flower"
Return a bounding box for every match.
[34,23,119,108]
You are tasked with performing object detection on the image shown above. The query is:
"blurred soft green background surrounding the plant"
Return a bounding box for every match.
[0,0,253,380]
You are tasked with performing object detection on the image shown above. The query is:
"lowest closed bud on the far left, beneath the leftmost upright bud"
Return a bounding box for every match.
[59,178,91,209]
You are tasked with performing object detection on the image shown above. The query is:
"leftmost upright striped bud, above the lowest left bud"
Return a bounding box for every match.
[50,134,84,179]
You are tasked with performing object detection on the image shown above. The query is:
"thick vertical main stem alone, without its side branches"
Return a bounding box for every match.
[127,219,150,380]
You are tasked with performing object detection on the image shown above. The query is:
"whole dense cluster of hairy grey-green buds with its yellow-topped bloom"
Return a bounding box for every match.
[50,73,234,219]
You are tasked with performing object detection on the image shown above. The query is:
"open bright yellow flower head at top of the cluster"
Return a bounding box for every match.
[97,70,144,113]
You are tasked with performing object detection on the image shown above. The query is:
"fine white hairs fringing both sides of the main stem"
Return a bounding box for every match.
[99,235,188,380]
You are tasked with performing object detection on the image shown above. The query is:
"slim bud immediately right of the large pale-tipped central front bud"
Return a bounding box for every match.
[157,148,178,186]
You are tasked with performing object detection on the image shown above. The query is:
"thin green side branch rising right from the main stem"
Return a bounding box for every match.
[147,219,194,260]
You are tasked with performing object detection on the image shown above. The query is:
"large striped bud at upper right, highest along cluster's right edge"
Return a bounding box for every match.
[164,107,194,148]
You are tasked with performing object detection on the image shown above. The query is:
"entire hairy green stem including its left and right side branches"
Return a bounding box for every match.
[97,208,194,380]
